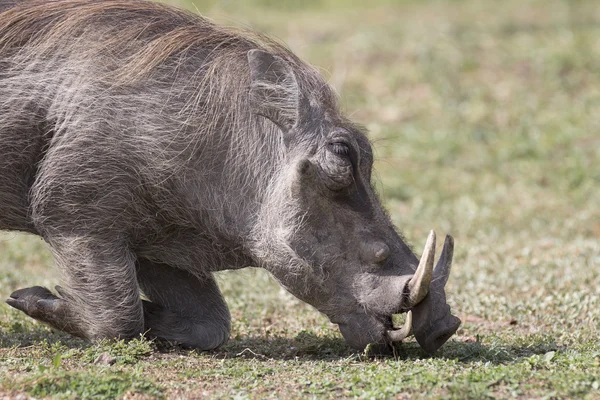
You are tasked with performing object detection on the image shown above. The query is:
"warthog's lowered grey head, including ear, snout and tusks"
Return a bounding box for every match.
[248,50,460,353]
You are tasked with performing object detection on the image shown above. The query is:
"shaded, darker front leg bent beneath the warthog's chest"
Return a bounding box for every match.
[137,260,231,350]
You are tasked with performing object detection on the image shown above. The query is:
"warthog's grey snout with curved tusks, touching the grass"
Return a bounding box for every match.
[331,231,460,353]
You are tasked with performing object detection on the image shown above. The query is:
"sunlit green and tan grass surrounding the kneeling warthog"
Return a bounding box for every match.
[0,0,600,399]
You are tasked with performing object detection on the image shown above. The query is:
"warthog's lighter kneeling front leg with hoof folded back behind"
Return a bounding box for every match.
[7,236,144,340]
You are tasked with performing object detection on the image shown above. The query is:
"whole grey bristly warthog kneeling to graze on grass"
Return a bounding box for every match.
[0,0,460,352]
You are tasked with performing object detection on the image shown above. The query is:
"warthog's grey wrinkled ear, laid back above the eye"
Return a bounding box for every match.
[248,49,300,132]
